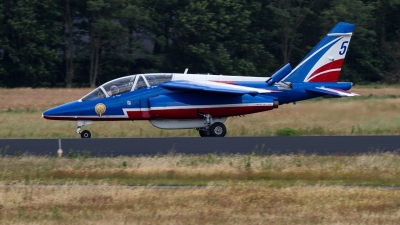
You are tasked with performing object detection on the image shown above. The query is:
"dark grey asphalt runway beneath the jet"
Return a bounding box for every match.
[0,136,400,157]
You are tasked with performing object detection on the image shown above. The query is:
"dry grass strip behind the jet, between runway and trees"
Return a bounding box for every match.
[0,87,400,138]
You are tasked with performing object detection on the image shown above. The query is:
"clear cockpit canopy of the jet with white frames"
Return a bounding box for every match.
[81,74,172,102]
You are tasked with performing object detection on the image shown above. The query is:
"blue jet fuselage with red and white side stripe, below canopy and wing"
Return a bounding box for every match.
[43,81,352,121]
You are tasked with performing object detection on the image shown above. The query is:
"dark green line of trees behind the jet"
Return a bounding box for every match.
[0,0,400,87]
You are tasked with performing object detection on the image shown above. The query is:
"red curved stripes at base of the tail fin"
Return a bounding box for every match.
[308,58,344,82]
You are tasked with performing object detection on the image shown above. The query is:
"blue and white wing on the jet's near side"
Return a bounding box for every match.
[161,80,277,96]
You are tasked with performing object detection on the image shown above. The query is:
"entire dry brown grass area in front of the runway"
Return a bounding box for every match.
[0,154,400,224]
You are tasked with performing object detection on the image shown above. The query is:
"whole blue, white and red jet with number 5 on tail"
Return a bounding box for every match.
[43,22,357,138]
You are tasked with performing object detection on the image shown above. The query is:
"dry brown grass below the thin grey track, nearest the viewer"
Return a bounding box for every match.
[0,186,400,224]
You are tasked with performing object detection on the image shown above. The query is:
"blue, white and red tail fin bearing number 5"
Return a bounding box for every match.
[282,22,354,83]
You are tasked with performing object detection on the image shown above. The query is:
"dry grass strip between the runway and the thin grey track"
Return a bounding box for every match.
[0,154,400,187]
